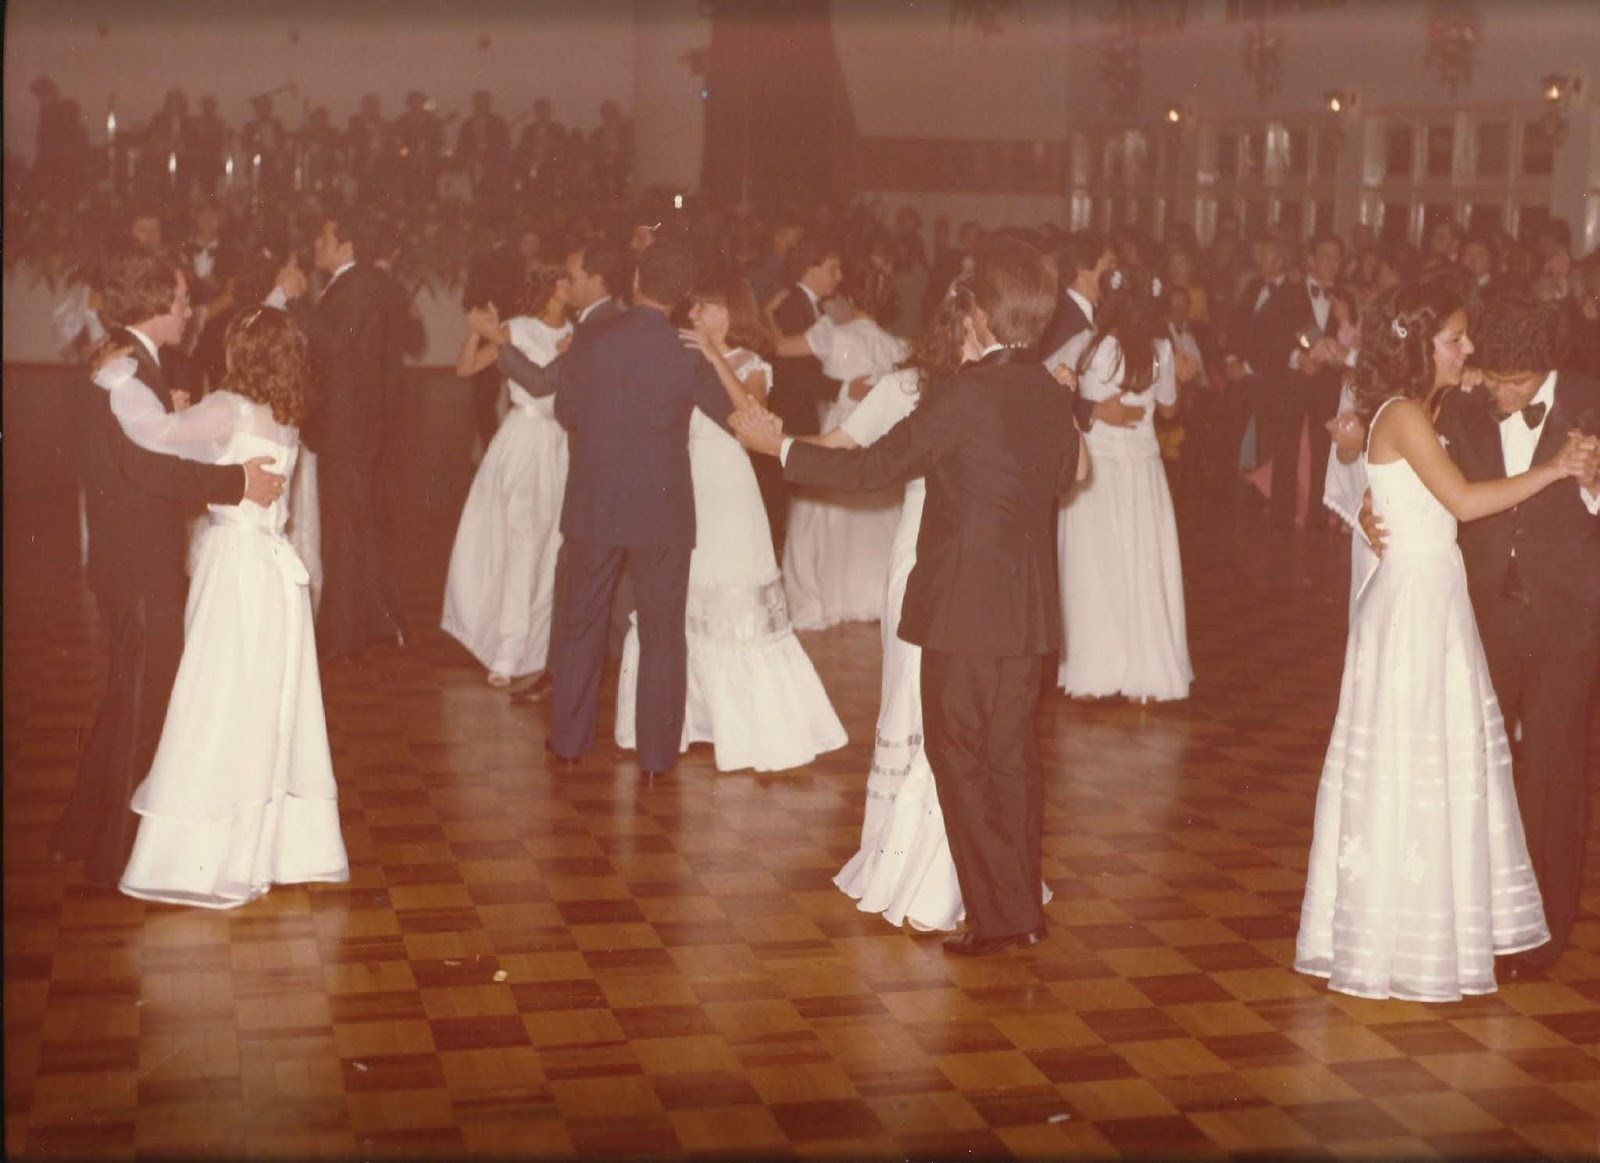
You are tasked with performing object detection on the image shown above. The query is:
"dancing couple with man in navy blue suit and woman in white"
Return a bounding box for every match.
[546,242,845,777]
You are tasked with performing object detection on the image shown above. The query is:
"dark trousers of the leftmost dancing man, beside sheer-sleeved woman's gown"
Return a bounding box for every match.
[50,590,184,886]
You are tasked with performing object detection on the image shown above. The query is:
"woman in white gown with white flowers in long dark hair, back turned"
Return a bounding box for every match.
[1056,267,1194,701]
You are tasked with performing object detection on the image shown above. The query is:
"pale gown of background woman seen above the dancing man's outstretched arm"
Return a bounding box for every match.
[784,315,906,630]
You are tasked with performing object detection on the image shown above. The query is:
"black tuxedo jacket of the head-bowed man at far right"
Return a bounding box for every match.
[1437,371,1600,635]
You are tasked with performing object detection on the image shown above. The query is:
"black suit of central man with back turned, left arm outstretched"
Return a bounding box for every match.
[784,349,1078,939]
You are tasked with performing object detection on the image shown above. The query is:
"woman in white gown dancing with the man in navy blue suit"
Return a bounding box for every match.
[616,280,848,771]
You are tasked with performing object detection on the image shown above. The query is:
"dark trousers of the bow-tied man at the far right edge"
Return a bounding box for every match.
[1478,597,1600,963]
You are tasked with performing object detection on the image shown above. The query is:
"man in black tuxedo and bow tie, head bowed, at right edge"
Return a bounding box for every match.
[1438,299,1600,976]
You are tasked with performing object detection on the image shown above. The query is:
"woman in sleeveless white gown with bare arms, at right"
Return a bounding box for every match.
[1294,285,1584,1001]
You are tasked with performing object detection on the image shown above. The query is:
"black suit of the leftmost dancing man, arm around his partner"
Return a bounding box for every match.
[51,345,245,885]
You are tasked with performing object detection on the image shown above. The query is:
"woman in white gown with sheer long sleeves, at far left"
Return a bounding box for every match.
[96,307,349,909]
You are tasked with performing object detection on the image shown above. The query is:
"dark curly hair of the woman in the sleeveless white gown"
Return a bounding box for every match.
[1355,282,1466,421]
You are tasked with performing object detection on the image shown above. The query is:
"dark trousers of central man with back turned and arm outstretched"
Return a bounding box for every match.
[922,646,1045,937]
